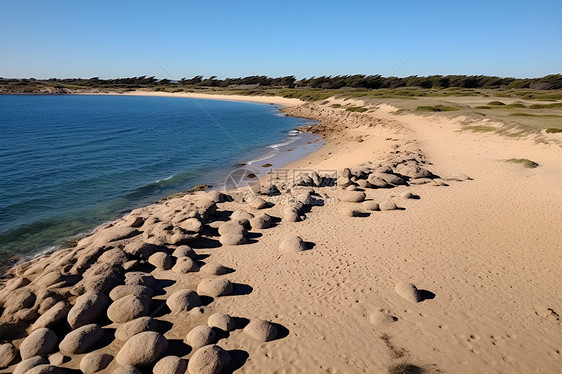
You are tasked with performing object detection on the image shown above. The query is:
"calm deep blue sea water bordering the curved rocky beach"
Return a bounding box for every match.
[0,96,305,263]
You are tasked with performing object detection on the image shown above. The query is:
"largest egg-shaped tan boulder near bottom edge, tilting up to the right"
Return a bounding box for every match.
[116,331,168,367]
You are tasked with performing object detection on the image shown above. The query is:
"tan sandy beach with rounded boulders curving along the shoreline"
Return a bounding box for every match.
[0,94,562,374]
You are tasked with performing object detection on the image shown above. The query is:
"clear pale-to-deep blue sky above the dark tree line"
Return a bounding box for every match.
[0,0,562,79]
